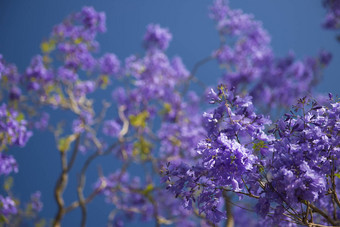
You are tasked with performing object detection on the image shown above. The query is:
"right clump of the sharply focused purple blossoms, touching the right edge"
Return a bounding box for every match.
[257,96,340,224]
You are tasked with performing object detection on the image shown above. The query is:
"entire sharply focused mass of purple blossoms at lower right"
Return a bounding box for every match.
[164,86,340,226]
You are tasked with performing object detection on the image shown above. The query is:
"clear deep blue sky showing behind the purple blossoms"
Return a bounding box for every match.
[0,0,340,226]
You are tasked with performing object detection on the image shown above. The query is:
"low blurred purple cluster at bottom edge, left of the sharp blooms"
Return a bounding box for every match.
[95,171,209,227]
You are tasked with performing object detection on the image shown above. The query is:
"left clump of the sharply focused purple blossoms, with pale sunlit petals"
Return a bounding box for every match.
[164,85,273,222]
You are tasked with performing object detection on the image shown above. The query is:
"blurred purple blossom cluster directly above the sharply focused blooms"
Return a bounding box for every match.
[210,0,331,112]
